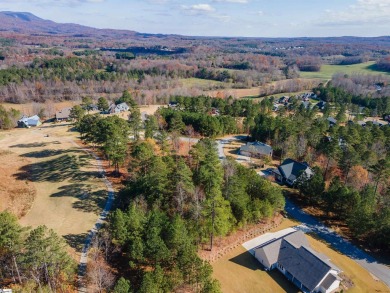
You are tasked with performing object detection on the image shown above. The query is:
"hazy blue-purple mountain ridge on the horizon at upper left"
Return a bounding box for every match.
[0,11,137,37]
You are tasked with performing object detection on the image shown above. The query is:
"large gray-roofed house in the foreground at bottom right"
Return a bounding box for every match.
[254,230,341,293]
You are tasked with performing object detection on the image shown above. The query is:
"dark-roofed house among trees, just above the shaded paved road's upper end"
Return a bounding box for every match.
[273,159,314,186]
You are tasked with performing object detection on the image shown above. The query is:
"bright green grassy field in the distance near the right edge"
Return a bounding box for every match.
[301,62,390,80]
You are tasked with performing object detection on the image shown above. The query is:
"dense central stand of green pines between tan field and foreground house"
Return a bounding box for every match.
[72,98,284,292]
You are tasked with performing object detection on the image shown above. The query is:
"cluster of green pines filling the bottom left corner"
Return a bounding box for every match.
[0,212,76,292]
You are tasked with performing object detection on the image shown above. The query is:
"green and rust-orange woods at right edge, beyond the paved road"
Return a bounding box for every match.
[251,96,390,250]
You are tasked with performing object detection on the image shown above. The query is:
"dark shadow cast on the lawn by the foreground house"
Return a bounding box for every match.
[229,251,301,293]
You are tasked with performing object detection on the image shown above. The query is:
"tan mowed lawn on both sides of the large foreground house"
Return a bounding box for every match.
[212,220,390,293]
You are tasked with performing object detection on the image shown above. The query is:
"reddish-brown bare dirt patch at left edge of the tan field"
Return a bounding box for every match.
[0,149,36,218]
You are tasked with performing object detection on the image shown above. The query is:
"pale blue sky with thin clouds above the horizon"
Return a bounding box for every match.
[0,0,390,37]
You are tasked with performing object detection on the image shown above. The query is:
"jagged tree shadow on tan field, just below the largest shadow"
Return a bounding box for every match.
[50,183,107,215]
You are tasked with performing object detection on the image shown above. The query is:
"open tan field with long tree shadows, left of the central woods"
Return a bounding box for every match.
[0,124,107,251]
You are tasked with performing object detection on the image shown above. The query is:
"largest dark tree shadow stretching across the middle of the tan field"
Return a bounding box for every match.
[14,154,93,182]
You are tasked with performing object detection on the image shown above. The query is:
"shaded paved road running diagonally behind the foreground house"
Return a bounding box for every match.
[285,199,390,287]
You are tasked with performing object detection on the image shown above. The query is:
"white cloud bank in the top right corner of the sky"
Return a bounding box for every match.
[320,0,390,26]
